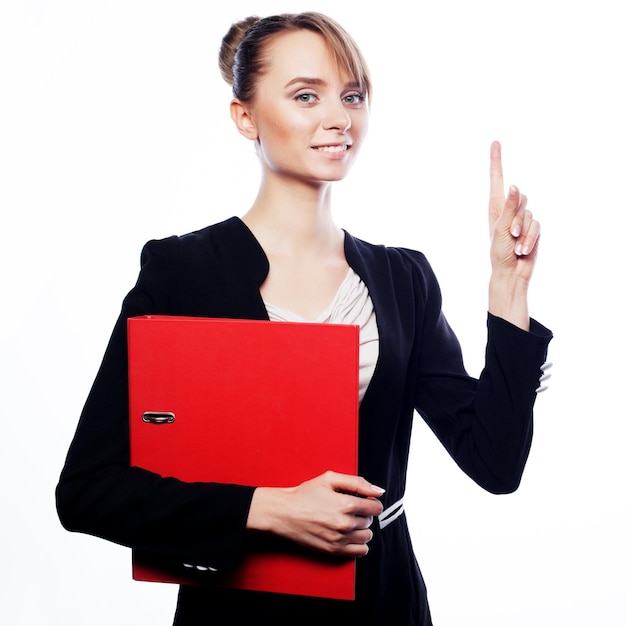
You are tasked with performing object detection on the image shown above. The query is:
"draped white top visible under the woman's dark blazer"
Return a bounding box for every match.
[265,268,378,402]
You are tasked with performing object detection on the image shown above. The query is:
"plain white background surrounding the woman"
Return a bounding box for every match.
[0,0,626,626]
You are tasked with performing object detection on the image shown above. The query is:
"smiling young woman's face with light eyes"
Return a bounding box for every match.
[239,30,368,184]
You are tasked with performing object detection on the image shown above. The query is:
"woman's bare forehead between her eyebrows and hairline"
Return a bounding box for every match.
[261,30,353,85]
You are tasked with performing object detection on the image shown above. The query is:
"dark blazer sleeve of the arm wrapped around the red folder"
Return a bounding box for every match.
[56,237,254,569]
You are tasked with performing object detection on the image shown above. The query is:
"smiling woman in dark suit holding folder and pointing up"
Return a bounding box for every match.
[57,13,551,625]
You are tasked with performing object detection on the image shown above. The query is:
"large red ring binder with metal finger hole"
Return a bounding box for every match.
[128,316,359,599]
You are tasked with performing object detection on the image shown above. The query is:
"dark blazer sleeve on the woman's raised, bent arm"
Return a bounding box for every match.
[414,252,552,493]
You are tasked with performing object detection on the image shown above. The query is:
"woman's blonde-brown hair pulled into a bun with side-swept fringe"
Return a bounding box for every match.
[219,12,372,102]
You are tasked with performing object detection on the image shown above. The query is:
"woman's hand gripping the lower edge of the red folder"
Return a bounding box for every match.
[248,472,384,557]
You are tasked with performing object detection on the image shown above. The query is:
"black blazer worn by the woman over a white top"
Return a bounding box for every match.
[57,218,551,626]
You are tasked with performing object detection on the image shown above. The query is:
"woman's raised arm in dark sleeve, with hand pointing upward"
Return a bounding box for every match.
[415,142,552,493]
